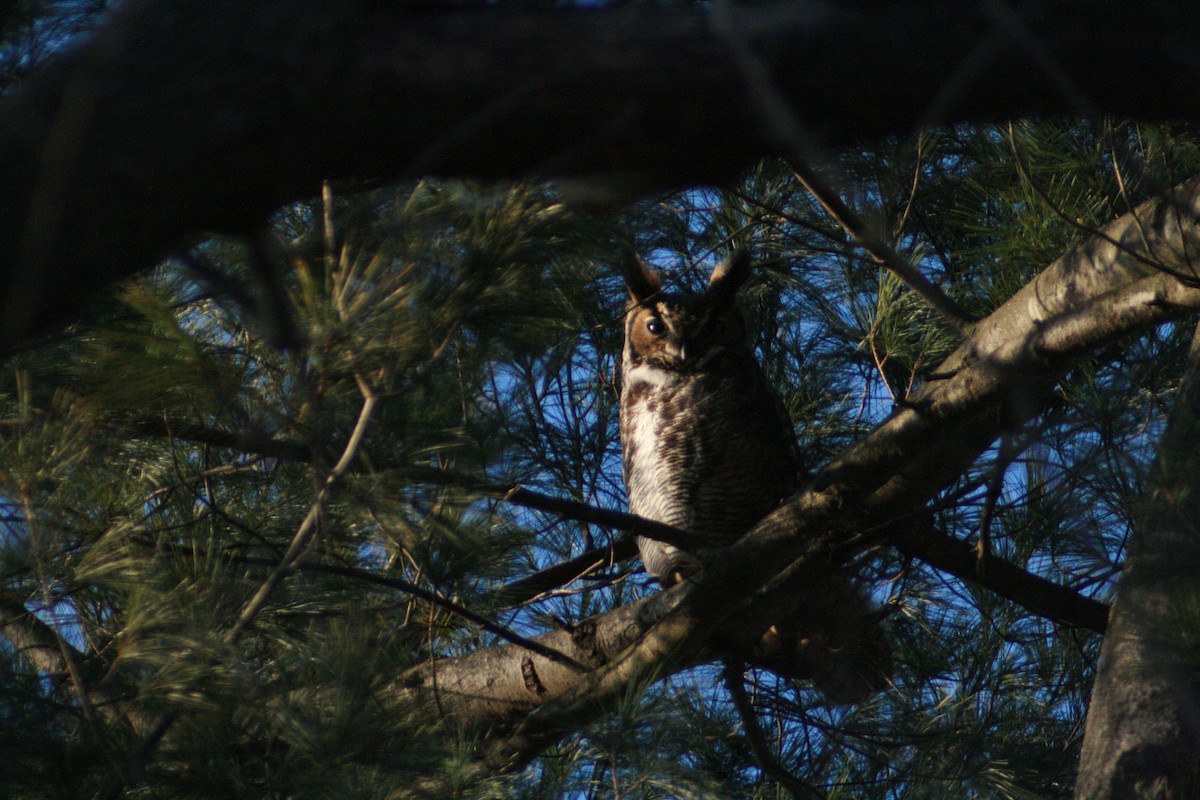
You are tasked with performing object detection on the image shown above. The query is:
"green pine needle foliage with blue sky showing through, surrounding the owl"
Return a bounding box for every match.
[0,115,1198,799]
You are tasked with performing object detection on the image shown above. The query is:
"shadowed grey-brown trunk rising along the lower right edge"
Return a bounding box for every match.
[1075,329,1200,800]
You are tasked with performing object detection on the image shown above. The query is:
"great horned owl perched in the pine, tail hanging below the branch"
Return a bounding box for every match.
[620,253,890,702]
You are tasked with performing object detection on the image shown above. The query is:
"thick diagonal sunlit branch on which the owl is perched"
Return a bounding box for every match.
[386,186,1200,771]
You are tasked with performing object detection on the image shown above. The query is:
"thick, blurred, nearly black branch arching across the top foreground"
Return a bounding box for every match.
[0,0,1200,351]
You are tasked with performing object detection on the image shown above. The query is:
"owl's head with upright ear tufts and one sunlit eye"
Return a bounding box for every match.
[625,251,750,373]
